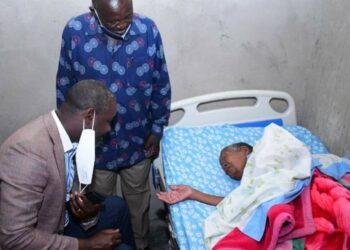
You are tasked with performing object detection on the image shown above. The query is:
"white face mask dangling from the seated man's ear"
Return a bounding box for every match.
[75,112,95,185]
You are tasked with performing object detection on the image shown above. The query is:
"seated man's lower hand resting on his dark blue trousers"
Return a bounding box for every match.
[79,229,122,250]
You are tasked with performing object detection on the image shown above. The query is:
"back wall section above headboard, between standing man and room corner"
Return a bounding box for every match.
[139,0,315,100]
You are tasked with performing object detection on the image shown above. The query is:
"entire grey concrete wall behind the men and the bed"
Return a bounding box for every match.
[0,0,350,154]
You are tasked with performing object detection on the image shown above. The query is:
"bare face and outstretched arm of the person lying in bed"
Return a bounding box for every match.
[157,142,253,206]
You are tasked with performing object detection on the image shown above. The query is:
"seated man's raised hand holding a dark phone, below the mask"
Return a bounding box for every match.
[70,192,100,220]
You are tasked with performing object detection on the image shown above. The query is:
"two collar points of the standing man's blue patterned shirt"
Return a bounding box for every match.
[85,12,141,40]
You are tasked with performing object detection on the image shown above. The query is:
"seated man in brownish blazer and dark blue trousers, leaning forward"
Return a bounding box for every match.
[0,80,134,250]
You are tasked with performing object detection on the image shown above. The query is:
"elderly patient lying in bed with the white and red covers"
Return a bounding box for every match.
[157,124,350,249]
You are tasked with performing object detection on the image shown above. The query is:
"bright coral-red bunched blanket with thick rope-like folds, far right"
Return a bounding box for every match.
[305,172,350,250]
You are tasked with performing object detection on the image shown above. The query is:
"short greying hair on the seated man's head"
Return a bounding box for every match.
[65,80,116,114]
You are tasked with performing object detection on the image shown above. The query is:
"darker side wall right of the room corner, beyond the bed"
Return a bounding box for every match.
[299,0,350,155]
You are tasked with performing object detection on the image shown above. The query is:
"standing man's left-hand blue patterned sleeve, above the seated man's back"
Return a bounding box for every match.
[56,23,79,108]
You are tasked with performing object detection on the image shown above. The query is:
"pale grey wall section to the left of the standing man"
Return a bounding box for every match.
[0,0,87,143]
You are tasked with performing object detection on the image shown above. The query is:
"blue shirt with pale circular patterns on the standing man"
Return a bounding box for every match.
[56,13,171,170]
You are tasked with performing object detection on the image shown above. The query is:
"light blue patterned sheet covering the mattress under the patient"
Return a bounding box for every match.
[161,125,328,250]
